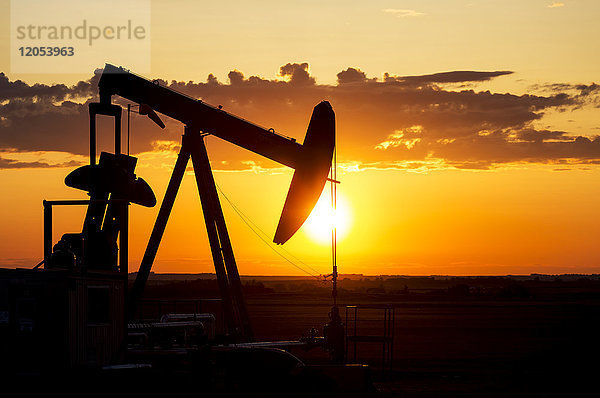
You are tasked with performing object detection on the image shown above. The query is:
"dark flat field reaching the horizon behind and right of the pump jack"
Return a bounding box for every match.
[138,278,600,397]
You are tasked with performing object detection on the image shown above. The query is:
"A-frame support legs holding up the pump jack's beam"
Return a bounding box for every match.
[129,126,252,341]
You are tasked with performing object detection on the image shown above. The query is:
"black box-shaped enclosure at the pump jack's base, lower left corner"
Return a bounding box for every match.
[0,268,126,374]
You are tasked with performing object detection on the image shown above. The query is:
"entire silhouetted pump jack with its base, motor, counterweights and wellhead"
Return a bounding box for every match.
[0,64,380,393]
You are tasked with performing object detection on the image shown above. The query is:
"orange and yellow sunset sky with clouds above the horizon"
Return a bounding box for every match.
[0,1,600,275]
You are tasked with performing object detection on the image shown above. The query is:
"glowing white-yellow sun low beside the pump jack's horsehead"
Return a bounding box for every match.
[303,187,351,244]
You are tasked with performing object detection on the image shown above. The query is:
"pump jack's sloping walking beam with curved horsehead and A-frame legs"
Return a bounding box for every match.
[98,64,335,341]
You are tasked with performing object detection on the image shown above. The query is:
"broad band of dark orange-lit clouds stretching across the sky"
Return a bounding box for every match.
[0,63,600,169]
